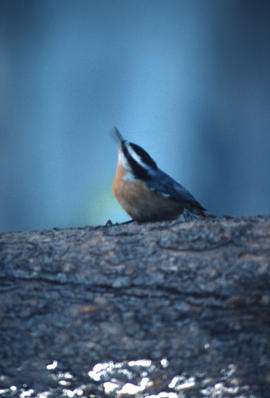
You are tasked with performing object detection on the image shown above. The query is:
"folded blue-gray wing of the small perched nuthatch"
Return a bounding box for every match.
[147,169,205,211]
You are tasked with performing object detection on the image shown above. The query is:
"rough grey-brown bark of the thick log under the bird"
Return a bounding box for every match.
[0,216,270,398]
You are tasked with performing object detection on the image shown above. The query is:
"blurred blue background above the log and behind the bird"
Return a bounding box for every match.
[0,0,270,232]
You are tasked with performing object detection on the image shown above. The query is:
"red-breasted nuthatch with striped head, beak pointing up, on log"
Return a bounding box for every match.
[113,128,205,221]
